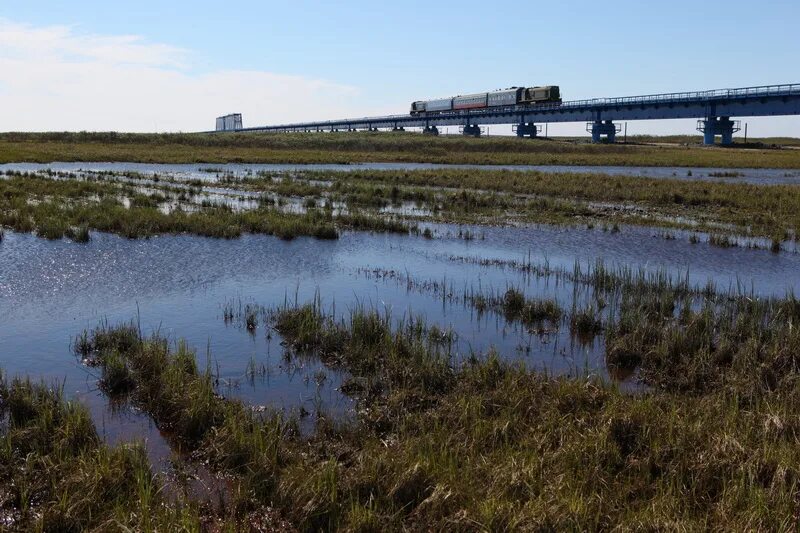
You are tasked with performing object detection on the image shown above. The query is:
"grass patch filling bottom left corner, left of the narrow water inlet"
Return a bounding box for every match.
[0,372,212,531]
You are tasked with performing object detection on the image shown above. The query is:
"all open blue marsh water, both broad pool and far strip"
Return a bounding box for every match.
[0,163,800,463]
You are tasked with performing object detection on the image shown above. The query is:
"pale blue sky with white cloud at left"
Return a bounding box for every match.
[0,0,800,137]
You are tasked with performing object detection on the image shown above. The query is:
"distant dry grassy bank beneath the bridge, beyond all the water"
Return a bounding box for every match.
[0,133,800,168]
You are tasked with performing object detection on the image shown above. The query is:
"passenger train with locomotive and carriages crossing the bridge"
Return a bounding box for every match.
[411,85,561,115]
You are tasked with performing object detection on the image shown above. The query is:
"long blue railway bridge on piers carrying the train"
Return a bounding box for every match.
[212,84,800,144]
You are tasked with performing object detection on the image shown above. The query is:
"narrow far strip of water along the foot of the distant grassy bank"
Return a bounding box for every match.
[0,163,800,185]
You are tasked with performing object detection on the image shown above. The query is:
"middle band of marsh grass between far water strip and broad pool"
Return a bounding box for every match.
[9,163,800,240]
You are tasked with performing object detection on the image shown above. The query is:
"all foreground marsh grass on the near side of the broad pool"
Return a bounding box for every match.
[9,255,800,531]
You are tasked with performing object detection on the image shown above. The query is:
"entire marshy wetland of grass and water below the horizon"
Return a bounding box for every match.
[0,134,800,531]
